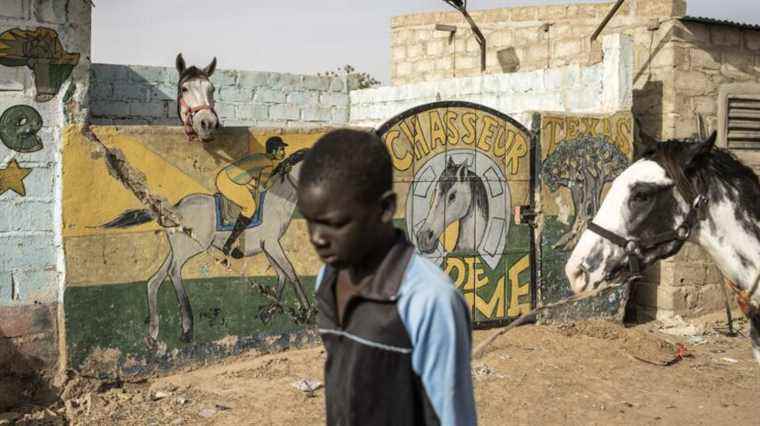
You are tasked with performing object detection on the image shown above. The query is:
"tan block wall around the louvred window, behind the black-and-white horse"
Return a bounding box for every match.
[634,21,760,317]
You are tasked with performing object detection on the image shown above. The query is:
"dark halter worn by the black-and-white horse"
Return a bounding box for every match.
[588,191,707,278]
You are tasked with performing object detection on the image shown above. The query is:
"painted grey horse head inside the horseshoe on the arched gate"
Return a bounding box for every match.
[416,157,489,253]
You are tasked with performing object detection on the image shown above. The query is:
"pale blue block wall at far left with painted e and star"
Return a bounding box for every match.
[0,0,90,390]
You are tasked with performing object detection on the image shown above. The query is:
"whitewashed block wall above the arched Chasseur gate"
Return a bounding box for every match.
[351,34,633,128]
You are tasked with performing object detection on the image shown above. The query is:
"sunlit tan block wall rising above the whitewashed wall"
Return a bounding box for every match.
[391,0,686,85]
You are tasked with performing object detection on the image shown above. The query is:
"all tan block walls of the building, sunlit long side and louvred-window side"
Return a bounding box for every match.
[388,0,760,316]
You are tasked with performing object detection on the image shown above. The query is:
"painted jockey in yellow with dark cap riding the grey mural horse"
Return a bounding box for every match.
[216,136,288,259]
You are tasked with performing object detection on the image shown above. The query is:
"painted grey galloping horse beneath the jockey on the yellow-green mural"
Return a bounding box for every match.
[103,149,313,351]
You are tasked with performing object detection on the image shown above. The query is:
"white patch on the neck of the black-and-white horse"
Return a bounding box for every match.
[694,184,760,298]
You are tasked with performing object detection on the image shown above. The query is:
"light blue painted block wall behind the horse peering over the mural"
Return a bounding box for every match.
[91,64,349,127]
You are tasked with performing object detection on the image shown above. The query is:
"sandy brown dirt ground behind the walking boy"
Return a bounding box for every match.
[5,315,760,425]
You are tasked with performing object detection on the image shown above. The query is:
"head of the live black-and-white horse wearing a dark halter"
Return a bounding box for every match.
[565,133,715,293]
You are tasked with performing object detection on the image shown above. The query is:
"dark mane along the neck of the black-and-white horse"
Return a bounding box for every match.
[645,139,760,218]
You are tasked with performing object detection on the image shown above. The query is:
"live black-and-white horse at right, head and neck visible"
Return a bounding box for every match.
[565,133,760,363]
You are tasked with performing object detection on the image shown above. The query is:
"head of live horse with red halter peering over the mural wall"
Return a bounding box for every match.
[177,53,219,142]
